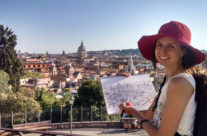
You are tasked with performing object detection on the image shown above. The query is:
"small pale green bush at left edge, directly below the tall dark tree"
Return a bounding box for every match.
[0,70,11,94]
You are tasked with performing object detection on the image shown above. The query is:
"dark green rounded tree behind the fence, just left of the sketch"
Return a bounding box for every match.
[75,79,105,107]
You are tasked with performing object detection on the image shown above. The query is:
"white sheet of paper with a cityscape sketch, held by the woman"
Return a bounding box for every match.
[101,74,156,115]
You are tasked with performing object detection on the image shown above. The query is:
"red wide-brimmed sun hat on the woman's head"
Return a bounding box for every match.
[138,21,205,64]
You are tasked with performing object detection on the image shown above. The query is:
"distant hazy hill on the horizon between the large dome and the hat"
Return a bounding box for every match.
[87,49,141,56]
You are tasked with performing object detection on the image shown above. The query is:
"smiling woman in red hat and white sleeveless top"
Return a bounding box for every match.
[120,21,206,136]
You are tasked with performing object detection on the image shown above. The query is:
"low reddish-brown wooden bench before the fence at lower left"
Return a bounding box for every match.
[12,120,51,131]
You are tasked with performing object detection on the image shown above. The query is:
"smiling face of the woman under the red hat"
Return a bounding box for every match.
[155,37,184,68]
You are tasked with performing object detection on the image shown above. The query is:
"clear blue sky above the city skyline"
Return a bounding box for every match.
[0,0,207,53]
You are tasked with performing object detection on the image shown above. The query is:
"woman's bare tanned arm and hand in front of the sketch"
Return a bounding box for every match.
[119,77,193,136]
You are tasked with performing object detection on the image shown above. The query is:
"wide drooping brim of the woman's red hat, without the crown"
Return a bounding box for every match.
[137,34,206,64]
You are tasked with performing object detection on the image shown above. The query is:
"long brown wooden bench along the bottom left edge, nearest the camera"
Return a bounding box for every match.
[0,128,83,136]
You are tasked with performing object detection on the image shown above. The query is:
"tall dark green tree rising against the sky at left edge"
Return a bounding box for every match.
[0,25,23,92]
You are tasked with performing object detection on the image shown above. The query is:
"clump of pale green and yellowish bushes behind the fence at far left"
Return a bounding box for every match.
[0,70,41,113]
